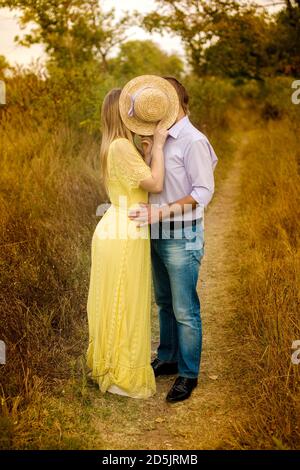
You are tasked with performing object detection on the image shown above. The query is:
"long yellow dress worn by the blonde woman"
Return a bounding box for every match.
[86,138,156,398]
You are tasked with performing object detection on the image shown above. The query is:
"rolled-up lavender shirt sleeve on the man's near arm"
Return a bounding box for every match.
[185,139,218,207]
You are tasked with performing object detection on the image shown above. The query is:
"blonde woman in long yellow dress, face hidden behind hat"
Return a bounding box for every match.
[87,77,180,398]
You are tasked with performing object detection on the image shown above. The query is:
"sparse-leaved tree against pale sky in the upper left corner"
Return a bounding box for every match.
[0,0,133,70]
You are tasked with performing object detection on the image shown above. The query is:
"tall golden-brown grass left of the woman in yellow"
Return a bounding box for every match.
[0,77,106,447]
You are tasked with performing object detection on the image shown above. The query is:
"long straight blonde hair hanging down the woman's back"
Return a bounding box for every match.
[100,88,133,191]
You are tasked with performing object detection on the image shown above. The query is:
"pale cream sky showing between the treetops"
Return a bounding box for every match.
[0,0,284,65]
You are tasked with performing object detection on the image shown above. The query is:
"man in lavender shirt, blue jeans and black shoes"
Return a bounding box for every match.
[130,77,218,402]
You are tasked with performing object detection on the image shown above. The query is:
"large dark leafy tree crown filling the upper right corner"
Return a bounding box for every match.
[144,0,300,79]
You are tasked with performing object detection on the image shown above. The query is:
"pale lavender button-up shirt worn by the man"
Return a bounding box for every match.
[150,116,218,220]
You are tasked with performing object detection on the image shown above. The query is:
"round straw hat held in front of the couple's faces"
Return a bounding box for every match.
[119,75,179,136]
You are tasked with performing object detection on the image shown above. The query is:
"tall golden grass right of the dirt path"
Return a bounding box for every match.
[232,117,300,449]
